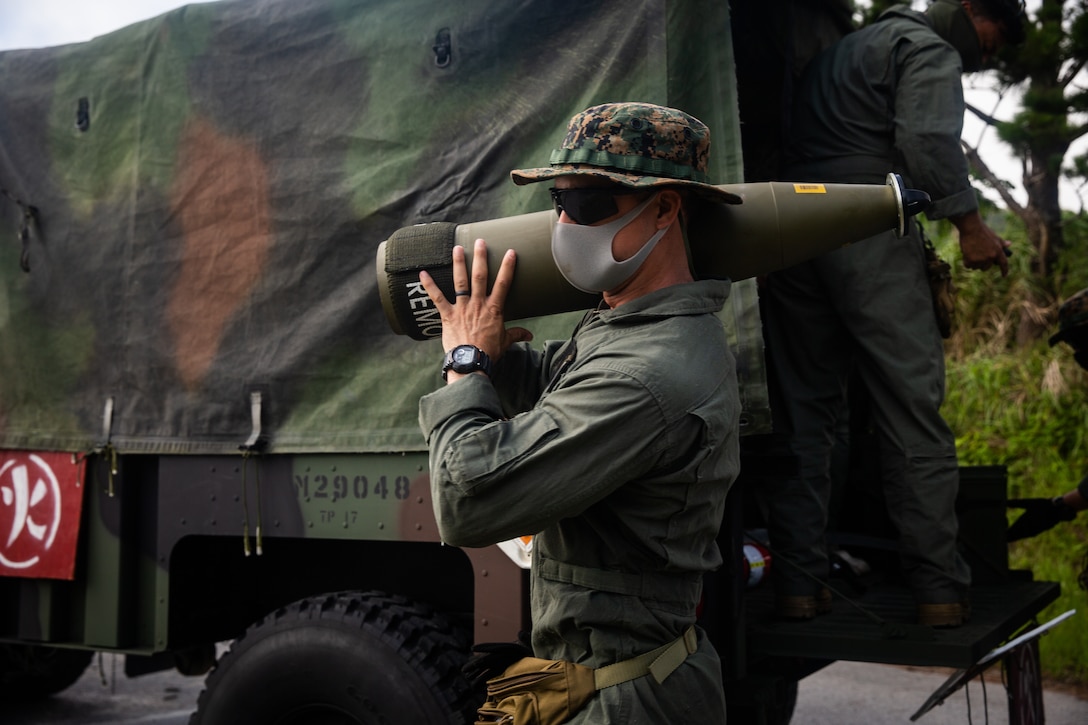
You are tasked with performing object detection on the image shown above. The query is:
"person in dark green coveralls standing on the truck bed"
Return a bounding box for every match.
[764,0,1024,627]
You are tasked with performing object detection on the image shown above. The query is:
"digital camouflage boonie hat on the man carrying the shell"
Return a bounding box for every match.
[510,102,741,204]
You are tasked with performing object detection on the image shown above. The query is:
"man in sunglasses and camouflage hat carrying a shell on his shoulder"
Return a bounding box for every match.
[420,103,740,725]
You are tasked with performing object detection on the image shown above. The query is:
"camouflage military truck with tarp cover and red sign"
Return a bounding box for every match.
[0,0,1056,724]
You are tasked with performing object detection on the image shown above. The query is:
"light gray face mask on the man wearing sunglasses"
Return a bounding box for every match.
[552,194,669,292]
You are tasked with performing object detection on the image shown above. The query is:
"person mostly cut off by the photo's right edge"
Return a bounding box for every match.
[1009,290,1088,544]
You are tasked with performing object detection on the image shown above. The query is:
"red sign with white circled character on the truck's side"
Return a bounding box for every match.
[0,451,86,579]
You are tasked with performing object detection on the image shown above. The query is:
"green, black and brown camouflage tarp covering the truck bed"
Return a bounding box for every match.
[0,0,767,453]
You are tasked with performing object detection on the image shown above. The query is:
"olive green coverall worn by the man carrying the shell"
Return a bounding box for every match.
[420,276,740,725]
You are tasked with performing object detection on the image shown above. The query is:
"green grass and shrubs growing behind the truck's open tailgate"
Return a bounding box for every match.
[926,213,1088,683]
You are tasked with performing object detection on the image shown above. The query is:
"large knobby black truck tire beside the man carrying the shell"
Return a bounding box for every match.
[189,592,475,725]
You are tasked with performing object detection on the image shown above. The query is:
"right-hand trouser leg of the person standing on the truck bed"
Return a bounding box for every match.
[837,226,970,603]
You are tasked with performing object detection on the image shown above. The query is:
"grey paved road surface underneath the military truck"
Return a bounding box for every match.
[0,655,1088,725]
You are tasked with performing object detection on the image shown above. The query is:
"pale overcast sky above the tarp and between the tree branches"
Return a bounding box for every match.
[0,0,1080,210]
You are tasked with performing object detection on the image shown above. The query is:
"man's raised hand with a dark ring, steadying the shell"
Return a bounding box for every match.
[419,239,533,382]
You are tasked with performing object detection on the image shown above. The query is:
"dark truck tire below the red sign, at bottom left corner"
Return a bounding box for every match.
[0,644,95,702]
